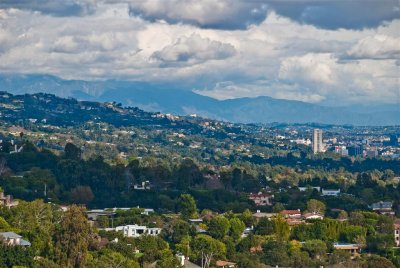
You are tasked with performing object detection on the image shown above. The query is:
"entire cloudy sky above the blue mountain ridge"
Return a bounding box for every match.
[0,0,400,105]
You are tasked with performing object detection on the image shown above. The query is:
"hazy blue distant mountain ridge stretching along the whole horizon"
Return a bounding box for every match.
[0,74,400,126]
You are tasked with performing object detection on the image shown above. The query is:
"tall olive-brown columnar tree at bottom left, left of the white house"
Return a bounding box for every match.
[55,205,91,268]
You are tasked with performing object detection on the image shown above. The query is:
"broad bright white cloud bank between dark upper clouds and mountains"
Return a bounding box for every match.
[0,4,400,103]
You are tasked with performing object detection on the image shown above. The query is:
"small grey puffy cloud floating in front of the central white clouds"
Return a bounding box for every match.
[153,34,235,65]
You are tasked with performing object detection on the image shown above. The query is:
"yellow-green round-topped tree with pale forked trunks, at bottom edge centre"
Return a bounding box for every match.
[192,235,226,268]
